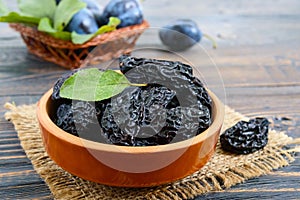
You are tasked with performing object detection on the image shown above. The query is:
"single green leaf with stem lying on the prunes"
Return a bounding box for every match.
[60,68,147,101]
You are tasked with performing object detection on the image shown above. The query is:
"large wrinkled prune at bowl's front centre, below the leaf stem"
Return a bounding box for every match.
[99,84,177,146]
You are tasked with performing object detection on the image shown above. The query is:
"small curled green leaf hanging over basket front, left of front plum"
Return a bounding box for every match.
[38,17,71,40]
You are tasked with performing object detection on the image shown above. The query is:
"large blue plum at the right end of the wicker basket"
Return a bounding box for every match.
[100,0,143,28]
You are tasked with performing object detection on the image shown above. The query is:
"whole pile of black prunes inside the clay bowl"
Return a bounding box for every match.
[52,56,212,146]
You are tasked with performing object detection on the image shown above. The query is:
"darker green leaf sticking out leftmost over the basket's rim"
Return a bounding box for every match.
[0,12,40,25]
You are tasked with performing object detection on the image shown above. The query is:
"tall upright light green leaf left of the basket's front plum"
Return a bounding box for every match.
[53,0,86,31]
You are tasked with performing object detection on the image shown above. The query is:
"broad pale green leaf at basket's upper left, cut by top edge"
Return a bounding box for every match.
[18,0,56,20]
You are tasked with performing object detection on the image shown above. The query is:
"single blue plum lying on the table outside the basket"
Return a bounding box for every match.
[159,19,202,51]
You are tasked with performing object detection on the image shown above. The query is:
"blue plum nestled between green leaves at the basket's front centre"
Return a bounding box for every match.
[65,8,99,34]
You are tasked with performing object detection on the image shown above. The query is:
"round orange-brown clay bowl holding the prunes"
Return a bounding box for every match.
[37,89,224,187]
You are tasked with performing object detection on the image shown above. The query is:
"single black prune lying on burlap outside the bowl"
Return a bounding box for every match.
[220,117,269,154]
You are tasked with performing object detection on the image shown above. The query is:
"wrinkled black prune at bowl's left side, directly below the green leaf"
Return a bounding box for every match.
[54,101,105,142]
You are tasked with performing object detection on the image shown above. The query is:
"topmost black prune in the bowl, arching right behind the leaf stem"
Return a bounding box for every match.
[119,56,211,107]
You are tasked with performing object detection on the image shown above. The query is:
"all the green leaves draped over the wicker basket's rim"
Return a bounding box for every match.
[0,0,121,44]
